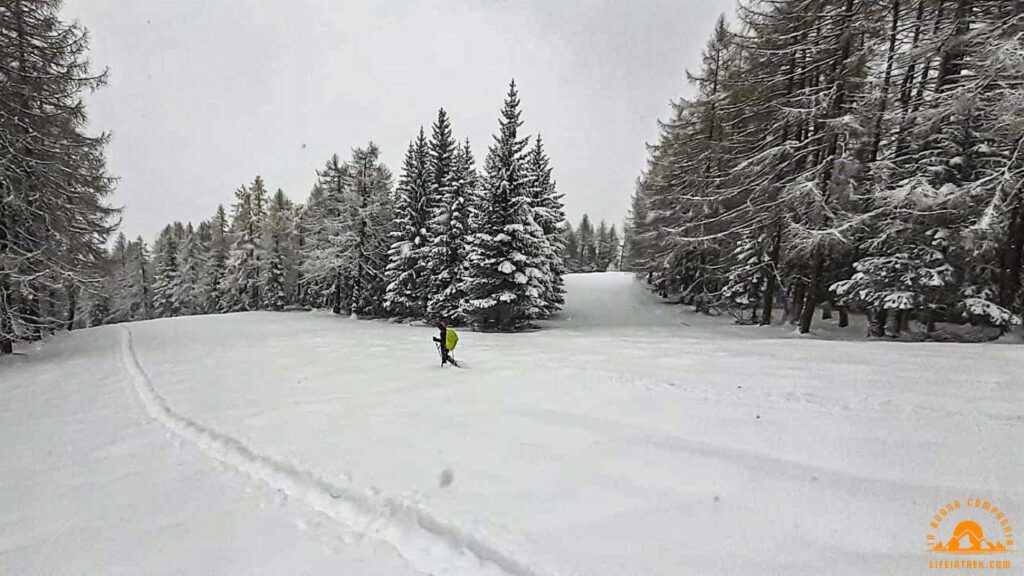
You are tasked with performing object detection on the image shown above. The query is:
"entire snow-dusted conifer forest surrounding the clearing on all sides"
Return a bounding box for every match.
[0,0,1024,354]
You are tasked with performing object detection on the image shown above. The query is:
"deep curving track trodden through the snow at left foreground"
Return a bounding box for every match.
[121,327,538,576]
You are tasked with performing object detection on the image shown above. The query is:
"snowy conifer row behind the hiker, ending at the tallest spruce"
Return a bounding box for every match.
[64,82,564,338]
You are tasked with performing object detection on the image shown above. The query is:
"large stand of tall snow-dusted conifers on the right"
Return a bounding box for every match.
[624,0,1024,336]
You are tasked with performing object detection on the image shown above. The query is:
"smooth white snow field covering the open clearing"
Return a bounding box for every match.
[0,273,1024,576]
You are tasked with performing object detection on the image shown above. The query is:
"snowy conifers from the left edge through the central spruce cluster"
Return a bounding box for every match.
[0,0,577,354]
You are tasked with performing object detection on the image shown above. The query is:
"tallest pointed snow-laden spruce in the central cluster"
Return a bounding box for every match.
[462,81,552,330]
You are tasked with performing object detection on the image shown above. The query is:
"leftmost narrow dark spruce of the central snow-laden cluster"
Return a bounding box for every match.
[384,128,433,319]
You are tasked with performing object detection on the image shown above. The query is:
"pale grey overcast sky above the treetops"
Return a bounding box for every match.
[63,0,734,240]
